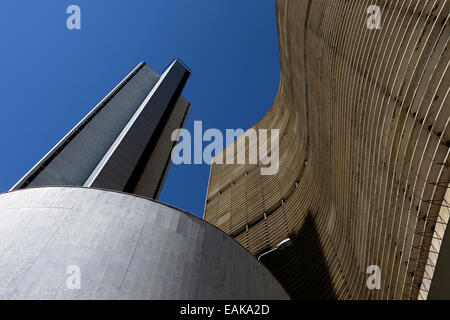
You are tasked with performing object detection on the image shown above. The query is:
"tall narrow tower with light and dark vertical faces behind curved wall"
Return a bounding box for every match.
[12,59,190,199]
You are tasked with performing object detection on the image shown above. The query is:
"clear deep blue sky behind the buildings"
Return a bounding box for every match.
[0,0,280,216]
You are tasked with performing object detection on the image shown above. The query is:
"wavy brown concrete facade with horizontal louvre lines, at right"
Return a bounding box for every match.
[205,0,450,299]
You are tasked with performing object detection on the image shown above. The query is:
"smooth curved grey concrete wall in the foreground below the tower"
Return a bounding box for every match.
[0,187,289,299]
